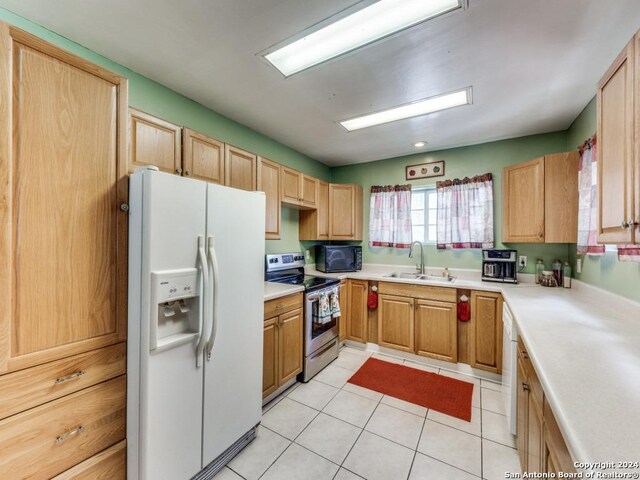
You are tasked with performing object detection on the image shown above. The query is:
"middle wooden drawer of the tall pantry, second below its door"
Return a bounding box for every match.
[0,375,126,480]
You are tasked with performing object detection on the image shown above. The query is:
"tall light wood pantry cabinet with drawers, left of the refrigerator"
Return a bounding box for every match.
[0,24,128,479]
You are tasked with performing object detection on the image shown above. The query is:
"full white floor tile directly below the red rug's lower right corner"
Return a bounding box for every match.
[418,420,482,478]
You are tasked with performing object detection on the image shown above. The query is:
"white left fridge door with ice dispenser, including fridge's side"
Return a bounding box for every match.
[127,171,206,480]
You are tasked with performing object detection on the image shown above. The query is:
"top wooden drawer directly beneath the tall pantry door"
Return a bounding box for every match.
[0,343,126,420]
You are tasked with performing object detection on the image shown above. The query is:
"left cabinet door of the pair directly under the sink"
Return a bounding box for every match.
[378,294,414,352]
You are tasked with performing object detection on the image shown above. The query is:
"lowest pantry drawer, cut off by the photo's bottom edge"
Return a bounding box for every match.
[52,440,127,480]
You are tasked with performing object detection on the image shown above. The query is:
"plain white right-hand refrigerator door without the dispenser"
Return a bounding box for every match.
[202,184,265,466]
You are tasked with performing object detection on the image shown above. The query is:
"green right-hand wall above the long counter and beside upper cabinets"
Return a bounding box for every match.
[567,97,640,300]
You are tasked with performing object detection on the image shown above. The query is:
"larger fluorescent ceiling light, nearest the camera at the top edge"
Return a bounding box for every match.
[263,0,465,77]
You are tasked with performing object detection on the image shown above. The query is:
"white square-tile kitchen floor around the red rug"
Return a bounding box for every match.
[215,347,520,480]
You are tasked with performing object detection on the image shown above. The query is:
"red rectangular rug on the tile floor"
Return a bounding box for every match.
[349,358,473,422]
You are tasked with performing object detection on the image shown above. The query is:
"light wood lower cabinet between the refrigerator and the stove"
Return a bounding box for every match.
[262,293,303,398]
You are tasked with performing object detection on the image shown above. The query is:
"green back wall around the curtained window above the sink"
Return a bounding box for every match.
[331,132,568,272]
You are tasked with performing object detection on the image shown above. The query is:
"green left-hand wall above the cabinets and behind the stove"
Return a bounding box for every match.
[0,7,330,253]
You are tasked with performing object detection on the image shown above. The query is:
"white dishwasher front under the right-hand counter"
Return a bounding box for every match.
[502,302,518,435]
